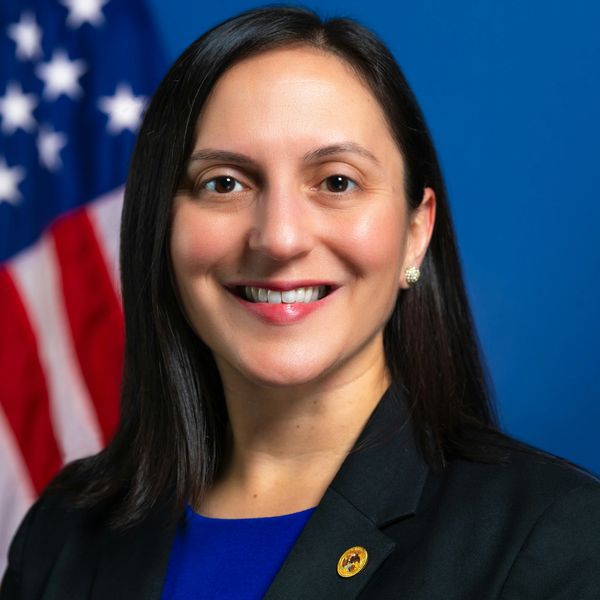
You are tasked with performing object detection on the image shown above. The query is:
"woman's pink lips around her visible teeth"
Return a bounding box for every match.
[226,279,339,325]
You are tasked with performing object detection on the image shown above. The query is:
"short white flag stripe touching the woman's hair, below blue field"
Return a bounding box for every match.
[86,188,123,295]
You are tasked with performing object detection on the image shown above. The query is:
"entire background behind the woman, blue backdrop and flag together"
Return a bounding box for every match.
[0,0,600,574]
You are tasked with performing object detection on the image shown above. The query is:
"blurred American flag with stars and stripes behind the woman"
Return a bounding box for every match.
[0,0,165,575]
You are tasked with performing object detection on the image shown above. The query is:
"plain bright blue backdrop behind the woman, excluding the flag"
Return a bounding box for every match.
[143,0,600,473]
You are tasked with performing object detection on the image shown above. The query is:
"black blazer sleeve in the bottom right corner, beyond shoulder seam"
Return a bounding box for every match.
[500,483,600,600]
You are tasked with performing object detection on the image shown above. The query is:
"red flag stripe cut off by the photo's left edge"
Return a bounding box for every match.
[0,268,62,493]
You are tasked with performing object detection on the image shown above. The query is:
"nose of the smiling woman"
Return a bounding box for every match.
[248,187,314,262]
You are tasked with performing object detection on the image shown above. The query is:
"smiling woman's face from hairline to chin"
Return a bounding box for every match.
[171,48,432,386]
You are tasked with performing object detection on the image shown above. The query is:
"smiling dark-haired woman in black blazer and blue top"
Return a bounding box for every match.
[0,8,600,600]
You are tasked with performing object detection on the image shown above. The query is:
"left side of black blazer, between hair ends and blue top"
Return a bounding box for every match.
[0,468,176,600]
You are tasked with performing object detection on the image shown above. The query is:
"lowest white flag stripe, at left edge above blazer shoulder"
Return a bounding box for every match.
[0,406,35,579]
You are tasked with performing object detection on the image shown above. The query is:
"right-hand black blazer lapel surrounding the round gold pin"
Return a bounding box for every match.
[265,387,428,600]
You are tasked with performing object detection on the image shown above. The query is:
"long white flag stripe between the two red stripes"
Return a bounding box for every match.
[9,235,102,462]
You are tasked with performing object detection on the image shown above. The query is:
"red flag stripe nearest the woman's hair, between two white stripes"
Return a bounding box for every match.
[52,210,123,442]
